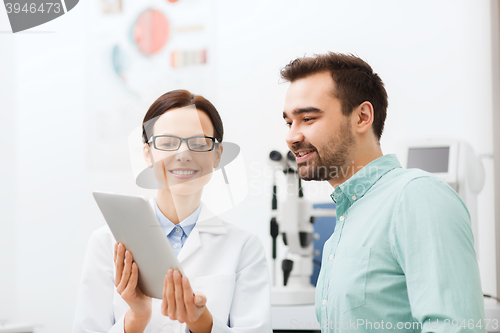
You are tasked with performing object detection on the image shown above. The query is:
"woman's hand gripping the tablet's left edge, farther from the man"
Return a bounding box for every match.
[113,243,152,332]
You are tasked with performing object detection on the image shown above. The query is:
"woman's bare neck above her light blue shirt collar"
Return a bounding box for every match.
[156,189,202,224]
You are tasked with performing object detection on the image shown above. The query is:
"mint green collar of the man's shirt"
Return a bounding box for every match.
[330,154,401,215]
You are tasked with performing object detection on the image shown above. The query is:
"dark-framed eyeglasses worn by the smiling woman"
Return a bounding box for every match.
[148,135,215,152]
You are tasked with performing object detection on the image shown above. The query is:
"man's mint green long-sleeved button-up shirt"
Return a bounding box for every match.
[316,155,486,333]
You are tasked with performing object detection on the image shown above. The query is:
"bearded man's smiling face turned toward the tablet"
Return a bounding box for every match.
[283,72,356,180]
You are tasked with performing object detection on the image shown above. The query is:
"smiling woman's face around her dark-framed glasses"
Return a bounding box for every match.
[143,107,222,195]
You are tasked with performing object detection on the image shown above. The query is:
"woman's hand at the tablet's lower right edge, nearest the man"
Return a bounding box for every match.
[161,269,213,333]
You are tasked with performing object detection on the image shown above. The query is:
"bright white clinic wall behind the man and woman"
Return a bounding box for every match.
[0,0,500,333]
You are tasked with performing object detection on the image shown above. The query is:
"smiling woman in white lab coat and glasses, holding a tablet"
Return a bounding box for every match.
[73,90,271,333]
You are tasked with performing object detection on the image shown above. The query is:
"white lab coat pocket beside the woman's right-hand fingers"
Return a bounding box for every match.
[191,273,236,322]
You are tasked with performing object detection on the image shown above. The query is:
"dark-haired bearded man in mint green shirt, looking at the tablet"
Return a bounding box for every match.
[281,53,486,332]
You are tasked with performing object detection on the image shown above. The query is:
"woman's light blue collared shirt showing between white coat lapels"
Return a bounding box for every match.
[154,199,201,256]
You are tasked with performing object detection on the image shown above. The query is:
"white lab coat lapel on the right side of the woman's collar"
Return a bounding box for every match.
[177,203,226,264]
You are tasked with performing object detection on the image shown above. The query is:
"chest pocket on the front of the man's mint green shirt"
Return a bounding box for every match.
[329,247,370,313]
